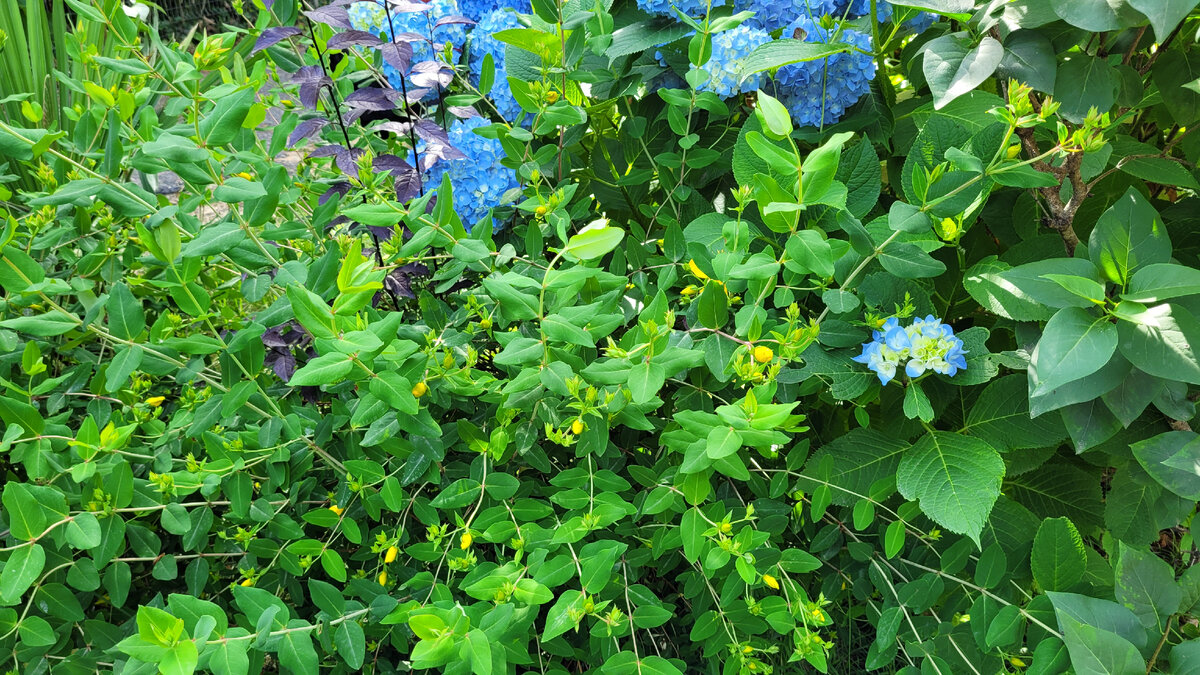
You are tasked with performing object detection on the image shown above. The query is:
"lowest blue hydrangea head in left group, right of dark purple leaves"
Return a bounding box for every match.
[425,118,518,231]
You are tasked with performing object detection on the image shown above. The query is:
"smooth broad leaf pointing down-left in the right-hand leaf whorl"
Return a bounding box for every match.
[1030,307,1117,394]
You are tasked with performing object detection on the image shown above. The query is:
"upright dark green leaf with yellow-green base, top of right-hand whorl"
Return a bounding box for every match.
[1087,187,1171,286]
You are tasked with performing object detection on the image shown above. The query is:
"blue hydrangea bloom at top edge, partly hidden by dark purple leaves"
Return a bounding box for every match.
[347,0,467,94]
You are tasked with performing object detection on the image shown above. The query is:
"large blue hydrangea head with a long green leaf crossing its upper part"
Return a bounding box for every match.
[775,17,875,127]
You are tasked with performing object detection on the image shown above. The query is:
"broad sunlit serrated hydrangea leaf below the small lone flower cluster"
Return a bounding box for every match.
[896,431,1004,544]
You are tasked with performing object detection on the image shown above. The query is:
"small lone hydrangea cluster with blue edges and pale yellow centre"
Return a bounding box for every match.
[853,315,967,386]
